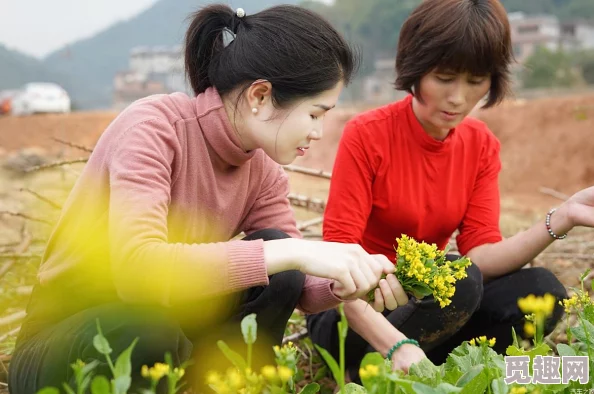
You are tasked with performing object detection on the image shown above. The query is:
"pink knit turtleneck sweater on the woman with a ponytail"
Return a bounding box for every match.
[39,88,341,313]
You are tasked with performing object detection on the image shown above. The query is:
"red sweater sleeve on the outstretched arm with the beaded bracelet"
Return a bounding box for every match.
[456,136,502,255]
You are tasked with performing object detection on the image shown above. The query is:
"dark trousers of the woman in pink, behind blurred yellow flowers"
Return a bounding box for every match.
[9,230,305,394]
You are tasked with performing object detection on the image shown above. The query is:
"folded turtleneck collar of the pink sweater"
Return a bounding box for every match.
[196,87,256,167]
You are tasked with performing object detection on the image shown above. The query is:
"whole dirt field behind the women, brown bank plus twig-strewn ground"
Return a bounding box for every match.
[0,94,594,389]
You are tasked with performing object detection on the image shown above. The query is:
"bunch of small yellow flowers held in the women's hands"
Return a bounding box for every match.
[369,234,472,308]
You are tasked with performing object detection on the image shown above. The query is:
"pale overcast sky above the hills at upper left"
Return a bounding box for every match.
[0,0,157,57]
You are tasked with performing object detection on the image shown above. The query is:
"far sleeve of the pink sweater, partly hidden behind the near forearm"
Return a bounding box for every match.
[244,166,342,313]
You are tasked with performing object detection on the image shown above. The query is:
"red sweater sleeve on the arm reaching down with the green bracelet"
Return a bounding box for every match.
[323,121,374,244]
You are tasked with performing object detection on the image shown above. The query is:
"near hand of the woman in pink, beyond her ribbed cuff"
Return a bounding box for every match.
[265,239,395,300]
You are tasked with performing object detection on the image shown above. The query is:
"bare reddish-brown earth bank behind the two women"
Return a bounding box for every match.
[0,94,594,199]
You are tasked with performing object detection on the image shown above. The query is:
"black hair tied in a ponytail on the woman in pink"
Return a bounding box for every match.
[185,4,358,107]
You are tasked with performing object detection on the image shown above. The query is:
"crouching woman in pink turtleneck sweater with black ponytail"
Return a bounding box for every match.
[10,5,394,394]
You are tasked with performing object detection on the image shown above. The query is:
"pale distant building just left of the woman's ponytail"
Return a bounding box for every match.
[113,46,190,110]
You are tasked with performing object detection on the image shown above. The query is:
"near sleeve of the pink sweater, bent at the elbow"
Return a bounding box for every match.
[107,120,268,306]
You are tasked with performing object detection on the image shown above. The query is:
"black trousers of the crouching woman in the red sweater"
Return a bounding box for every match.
[307,255,567,382]
